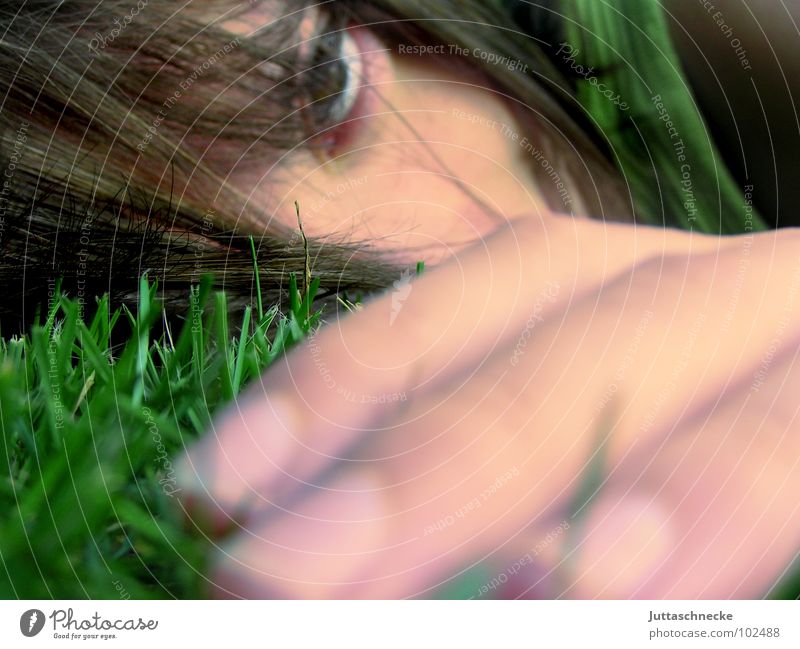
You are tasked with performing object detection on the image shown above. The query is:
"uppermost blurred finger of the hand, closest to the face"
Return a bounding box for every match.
[179,217,719,515]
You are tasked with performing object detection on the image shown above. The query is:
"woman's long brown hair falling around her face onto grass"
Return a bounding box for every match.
[0,0,627,333]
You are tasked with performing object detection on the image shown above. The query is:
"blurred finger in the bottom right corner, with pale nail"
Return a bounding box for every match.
[560,340,800,599]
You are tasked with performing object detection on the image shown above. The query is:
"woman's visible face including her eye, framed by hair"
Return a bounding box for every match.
[225,9,560,263]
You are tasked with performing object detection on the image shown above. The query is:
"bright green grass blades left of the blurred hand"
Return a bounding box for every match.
[0,248,319,599]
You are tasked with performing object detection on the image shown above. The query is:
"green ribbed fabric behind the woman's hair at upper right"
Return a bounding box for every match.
[557,0,765,233]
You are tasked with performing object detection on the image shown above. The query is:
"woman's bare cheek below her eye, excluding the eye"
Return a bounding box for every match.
[260,70,543,263]
